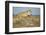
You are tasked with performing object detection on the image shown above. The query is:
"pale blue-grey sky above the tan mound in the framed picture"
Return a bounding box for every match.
[13,7,40,15]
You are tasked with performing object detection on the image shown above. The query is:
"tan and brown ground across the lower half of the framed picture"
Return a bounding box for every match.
[13,16,40,28]
